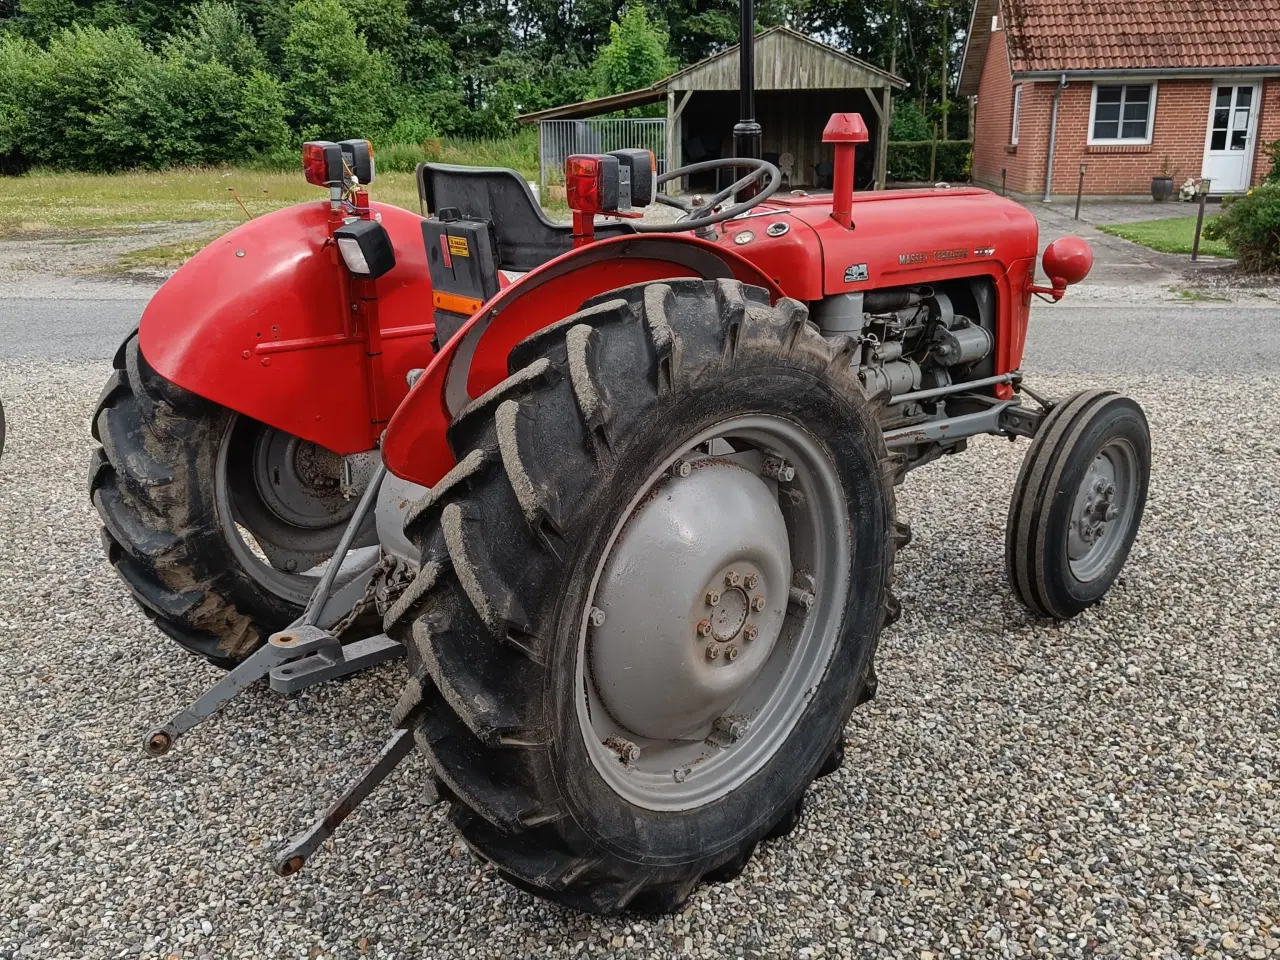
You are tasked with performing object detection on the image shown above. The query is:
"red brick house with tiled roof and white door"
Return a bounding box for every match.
[959,0,1280,198]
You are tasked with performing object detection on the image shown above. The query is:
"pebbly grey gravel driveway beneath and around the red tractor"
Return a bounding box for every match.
[0,296,1280,960]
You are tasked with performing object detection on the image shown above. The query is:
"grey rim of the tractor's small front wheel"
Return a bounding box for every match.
[1066,438,1138,582]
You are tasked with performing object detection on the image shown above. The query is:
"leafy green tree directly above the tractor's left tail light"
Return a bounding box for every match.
[283,0,393,140]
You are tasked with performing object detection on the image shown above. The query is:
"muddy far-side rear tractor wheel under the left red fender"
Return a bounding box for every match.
[90,334,375,668]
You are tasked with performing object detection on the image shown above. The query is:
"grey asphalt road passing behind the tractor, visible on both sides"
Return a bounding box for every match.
[0,283,1280,376]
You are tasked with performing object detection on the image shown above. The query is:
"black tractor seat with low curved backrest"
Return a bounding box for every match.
[417,164,635,273]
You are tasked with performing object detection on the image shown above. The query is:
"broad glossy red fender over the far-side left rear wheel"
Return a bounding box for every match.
[138,200,435,454]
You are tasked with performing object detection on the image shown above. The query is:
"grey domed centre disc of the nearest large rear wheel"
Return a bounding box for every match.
[590,458,791,740]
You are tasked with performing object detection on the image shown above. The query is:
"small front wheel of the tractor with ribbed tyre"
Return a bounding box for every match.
[1005,390,1151,620]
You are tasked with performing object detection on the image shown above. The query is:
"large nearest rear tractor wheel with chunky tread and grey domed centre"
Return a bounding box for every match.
[387,280,897,914]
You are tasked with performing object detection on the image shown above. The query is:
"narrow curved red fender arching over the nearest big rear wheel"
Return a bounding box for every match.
[383,234,782,486]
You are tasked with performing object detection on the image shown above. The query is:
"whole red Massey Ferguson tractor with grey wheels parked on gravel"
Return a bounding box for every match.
[90,4,1149,913]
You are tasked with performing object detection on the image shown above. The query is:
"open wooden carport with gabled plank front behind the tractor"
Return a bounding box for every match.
[520,27,908,189]
